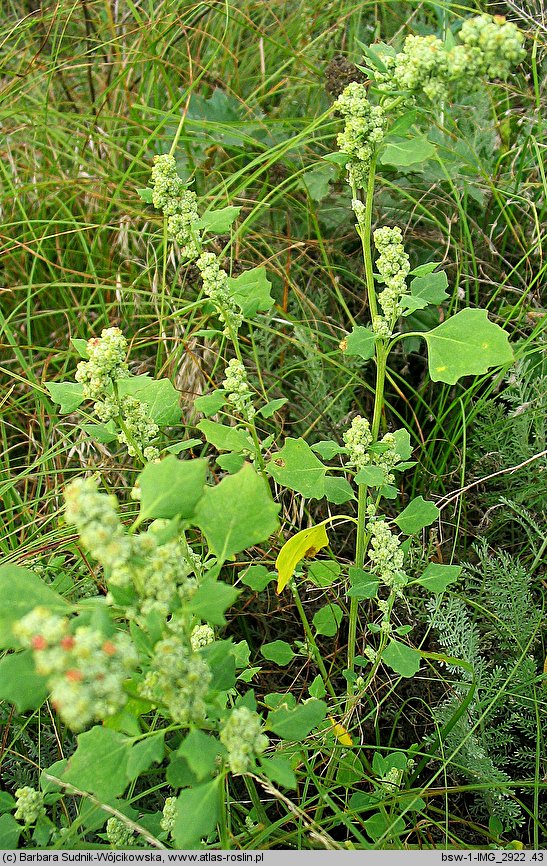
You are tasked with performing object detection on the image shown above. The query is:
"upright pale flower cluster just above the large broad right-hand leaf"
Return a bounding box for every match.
[372,226,410,337]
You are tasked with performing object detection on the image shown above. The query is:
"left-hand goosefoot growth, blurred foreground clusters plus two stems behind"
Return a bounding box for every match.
[0,181,292,848]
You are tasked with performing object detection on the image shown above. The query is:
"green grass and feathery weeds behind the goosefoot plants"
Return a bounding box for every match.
[0,0,547,847]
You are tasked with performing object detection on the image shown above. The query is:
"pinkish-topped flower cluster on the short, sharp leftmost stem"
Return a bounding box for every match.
[76,328,159,461]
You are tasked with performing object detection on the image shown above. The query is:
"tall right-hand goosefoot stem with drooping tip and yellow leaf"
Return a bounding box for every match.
[260,10,524,842]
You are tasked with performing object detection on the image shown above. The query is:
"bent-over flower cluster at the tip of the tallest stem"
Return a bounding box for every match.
[375,15,526,102]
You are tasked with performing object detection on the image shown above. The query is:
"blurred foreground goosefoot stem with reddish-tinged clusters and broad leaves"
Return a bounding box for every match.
[0,446,282,848]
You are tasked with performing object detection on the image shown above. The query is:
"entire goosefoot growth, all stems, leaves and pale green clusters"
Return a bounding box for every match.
[0,16,522,848]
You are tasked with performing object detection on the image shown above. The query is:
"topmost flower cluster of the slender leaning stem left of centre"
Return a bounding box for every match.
[152,154,201,260]
